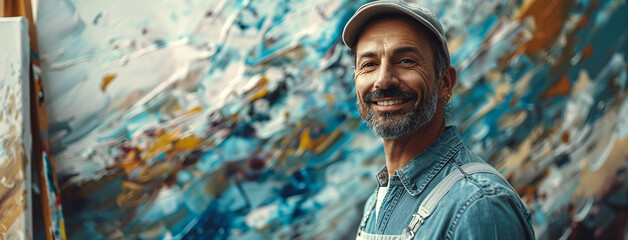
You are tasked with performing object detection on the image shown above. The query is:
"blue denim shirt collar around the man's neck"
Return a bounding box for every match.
[377,126,463,196]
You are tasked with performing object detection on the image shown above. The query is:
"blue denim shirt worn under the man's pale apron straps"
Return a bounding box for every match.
[364,126,534,239]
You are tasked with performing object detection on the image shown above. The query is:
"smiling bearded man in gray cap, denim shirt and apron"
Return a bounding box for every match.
[342,0,534,239]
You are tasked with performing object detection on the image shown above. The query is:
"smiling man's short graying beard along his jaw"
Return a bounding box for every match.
[357,91,438,139]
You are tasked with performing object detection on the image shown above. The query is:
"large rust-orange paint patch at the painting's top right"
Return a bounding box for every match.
[516,0,573,55]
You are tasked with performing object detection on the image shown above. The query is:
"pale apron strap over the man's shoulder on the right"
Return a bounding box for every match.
[401,162,514,239]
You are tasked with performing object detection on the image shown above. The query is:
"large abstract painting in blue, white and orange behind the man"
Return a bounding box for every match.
[37,0,628,239]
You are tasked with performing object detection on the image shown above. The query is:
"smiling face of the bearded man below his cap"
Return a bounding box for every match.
[355,19,438,139]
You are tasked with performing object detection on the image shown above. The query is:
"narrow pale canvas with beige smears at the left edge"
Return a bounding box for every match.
[0,17,33,239]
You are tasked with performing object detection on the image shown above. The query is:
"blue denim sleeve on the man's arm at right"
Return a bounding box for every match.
[446,191,534,239]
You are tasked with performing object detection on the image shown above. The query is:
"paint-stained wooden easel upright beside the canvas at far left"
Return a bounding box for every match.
[0,0,66,240]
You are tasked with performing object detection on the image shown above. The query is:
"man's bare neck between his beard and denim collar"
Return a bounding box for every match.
[384,112,445,176]
